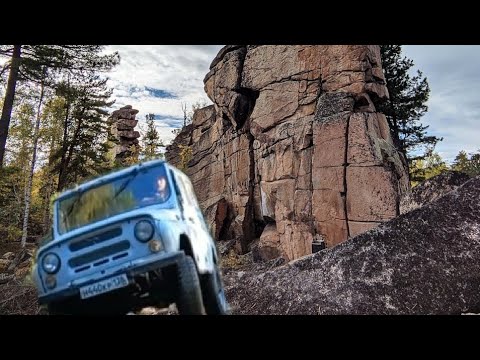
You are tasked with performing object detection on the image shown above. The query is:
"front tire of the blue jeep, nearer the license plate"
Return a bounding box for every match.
[176,255,205,315]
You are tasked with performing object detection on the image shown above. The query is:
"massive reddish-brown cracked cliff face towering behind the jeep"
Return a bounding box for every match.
[167,45,408,260]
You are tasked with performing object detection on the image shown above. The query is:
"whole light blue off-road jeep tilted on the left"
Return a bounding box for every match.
[33,160,228,314]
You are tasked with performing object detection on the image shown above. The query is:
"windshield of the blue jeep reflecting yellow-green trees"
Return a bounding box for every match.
[58,164,171,234]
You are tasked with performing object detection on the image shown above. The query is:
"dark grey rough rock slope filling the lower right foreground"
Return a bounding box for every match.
[223,176,480,314]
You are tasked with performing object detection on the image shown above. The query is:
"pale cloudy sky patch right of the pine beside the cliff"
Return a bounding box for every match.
[403,45,480,161]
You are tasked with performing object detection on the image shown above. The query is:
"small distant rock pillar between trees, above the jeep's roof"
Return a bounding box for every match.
[108,105,140,161]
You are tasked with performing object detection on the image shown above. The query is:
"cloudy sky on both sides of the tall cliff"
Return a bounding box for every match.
[107,45,480,162]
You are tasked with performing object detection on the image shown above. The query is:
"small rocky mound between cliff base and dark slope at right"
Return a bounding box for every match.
[400,171,470,214]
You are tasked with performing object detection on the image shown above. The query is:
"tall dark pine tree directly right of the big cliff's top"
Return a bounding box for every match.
[375,45,442,165]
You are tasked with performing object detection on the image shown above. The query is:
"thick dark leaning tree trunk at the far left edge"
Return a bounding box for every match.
[0,45,22,168]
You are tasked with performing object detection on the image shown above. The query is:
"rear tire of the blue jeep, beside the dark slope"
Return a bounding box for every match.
[203,264,229,315]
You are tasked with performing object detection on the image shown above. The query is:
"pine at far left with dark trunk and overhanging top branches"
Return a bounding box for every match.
[0,45,119,167]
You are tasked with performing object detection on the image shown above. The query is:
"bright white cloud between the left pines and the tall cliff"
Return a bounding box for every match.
[107,45,222,143]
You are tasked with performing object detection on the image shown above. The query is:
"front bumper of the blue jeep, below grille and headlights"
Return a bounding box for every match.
[38,251,185,305]
